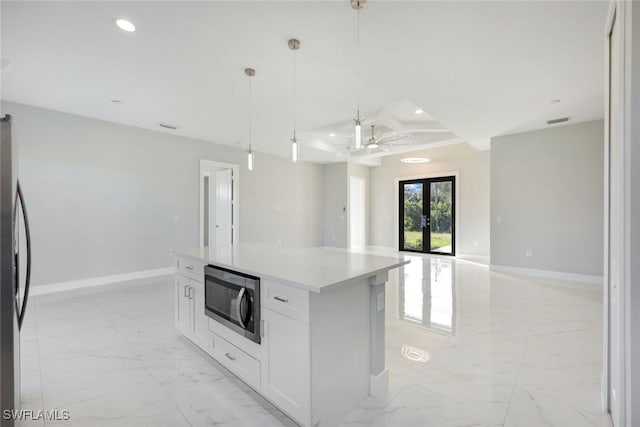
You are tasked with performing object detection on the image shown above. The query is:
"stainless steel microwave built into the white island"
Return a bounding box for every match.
[204,265,260,344]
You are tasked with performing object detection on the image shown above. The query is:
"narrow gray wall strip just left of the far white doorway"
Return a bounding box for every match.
[323,163,349,248]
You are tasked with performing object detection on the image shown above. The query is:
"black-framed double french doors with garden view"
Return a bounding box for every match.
[398,176,456,255]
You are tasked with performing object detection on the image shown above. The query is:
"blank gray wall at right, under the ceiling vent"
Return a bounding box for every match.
[491,120,604,276]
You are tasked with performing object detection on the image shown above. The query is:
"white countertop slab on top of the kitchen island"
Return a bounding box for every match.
[173,244,409,292]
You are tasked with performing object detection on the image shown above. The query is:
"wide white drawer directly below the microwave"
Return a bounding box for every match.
[208,332,260,390]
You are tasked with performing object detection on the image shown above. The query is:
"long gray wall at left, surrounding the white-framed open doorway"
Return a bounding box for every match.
[2,102,323,285]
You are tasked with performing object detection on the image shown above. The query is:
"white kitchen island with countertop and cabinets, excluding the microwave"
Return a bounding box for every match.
[174,245,408,426]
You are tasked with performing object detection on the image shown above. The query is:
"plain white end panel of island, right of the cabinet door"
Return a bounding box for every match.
[310,278,370,426]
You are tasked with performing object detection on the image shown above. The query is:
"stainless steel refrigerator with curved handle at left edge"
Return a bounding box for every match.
[0,115,31,427]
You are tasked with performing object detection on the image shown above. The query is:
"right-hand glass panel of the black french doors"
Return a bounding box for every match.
[430,181,453,253]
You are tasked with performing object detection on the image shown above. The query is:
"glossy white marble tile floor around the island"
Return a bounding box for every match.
[20,255,611,427]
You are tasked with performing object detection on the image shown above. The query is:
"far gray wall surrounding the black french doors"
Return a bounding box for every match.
[369,144,489,256]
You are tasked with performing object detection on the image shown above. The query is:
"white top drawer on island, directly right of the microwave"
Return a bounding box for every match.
[261,280,309,323]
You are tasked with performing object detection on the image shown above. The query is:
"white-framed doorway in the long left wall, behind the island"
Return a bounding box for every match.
[199,160,239,247]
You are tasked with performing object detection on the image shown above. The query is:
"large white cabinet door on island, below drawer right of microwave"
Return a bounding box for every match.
[262,308,311,425]
